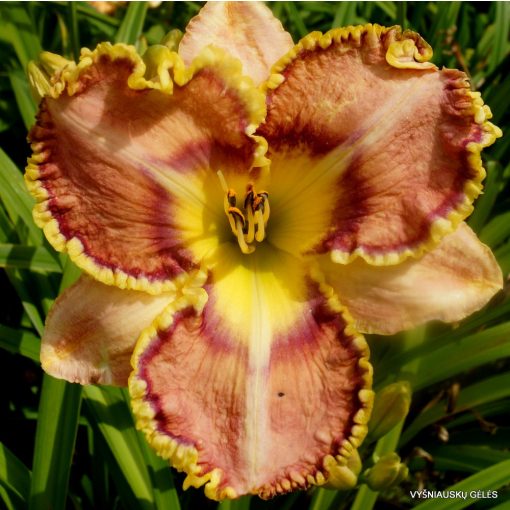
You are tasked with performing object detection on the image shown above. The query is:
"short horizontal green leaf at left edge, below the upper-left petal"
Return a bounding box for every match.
[0,244,62,273]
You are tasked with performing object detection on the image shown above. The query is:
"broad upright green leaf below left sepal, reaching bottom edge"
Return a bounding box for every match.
[29,374,82,510]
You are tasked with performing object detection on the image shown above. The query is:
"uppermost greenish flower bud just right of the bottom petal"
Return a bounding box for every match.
[368,381,411,441]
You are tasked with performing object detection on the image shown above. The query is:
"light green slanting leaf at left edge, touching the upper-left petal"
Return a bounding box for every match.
[0,148,42,246]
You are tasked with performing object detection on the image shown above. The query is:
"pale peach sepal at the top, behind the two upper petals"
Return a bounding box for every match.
[179,2,294,83]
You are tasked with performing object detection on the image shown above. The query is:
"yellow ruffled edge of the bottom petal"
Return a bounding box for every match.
[128,269,374,501]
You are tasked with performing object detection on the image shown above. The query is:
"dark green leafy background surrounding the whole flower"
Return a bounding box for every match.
[0,2,510,510]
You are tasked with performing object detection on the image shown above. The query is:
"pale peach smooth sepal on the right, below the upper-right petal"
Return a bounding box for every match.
[321,223,503,334]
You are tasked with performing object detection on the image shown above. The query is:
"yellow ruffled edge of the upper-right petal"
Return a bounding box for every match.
[261,24,503,266]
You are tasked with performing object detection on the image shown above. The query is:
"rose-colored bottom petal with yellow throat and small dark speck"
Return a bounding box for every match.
[130,243,372,499]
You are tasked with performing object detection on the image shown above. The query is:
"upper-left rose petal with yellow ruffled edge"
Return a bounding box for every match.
[26,43,265,293]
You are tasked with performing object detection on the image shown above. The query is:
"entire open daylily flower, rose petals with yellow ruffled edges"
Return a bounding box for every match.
[26,2,502,499]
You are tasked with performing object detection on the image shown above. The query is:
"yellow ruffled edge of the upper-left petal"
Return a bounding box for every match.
[25,42,269,294]
